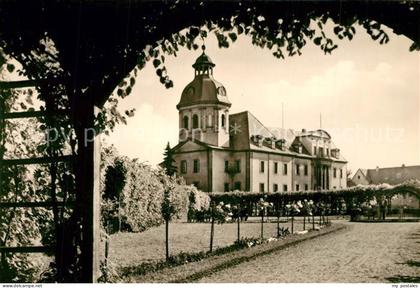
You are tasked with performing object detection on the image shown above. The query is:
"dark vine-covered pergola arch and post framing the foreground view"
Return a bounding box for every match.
[0,0,420,282]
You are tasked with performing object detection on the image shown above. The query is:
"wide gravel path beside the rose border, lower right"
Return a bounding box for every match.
[200,222,420,283]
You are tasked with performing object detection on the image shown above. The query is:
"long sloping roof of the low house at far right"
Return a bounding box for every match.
[366,165,420,185]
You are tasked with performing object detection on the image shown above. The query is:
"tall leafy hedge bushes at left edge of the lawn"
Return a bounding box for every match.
[101,146,210,233]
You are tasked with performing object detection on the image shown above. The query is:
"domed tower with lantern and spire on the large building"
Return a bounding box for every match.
[176,45,232,146]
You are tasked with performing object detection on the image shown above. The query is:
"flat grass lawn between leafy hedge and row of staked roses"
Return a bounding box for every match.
[105,219,312,267]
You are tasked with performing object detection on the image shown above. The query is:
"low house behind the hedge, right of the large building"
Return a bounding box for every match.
[351,164,420,208]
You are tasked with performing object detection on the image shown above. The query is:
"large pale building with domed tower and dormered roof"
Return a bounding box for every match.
[173,51,347,192]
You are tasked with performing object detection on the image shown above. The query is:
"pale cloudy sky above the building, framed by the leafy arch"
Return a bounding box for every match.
[103,22,420,173]
